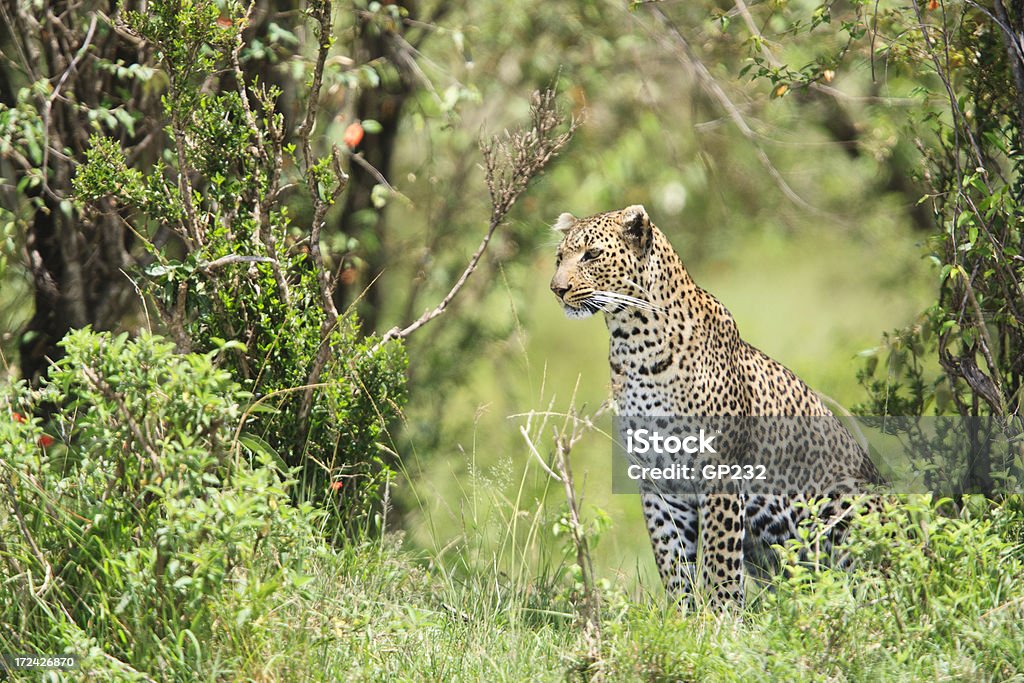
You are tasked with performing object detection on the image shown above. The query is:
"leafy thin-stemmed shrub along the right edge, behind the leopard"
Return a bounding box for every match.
[800,0,1024,423]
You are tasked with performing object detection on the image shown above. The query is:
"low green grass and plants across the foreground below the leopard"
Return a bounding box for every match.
[90,493,1024,681]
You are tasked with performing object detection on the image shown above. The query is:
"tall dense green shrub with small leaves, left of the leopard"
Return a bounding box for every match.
[74,1,406,530]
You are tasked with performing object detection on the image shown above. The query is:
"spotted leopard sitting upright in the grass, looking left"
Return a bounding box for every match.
[550,205,883,605]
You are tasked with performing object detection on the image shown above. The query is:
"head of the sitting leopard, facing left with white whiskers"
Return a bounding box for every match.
[551,205,653,317]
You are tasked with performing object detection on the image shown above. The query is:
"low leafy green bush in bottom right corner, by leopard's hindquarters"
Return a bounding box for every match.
[758,496,1024,680]
